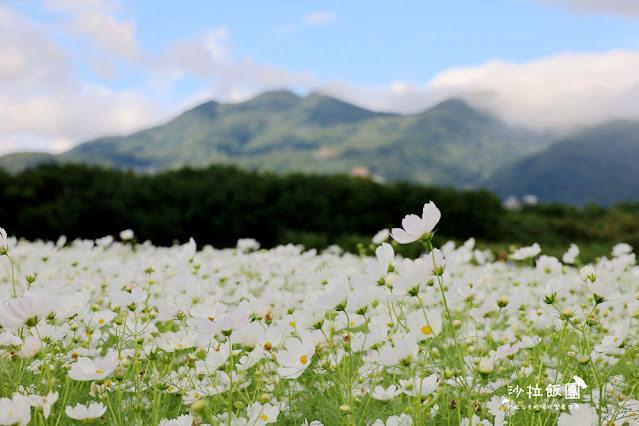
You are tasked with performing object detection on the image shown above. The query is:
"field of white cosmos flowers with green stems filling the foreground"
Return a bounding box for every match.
[0,203,639,426]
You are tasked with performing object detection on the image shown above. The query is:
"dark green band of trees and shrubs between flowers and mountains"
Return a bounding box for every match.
[0,164,639,260]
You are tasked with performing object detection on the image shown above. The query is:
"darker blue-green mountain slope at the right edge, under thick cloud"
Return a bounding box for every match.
[485,121,639,205]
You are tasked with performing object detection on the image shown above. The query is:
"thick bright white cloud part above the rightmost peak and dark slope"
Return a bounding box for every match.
[429,51,639,127]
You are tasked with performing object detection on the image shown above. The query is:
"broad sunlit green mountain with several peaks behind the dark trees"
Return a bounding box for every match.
[0,91,548,188]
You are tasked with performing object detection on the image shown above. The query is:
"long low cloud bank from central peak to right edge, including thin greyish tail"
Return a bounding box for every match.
[321,51,639,128]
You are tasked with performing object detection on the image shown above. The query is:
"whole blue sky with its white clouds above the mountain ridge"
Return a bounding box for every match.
[0,0,639,152]
